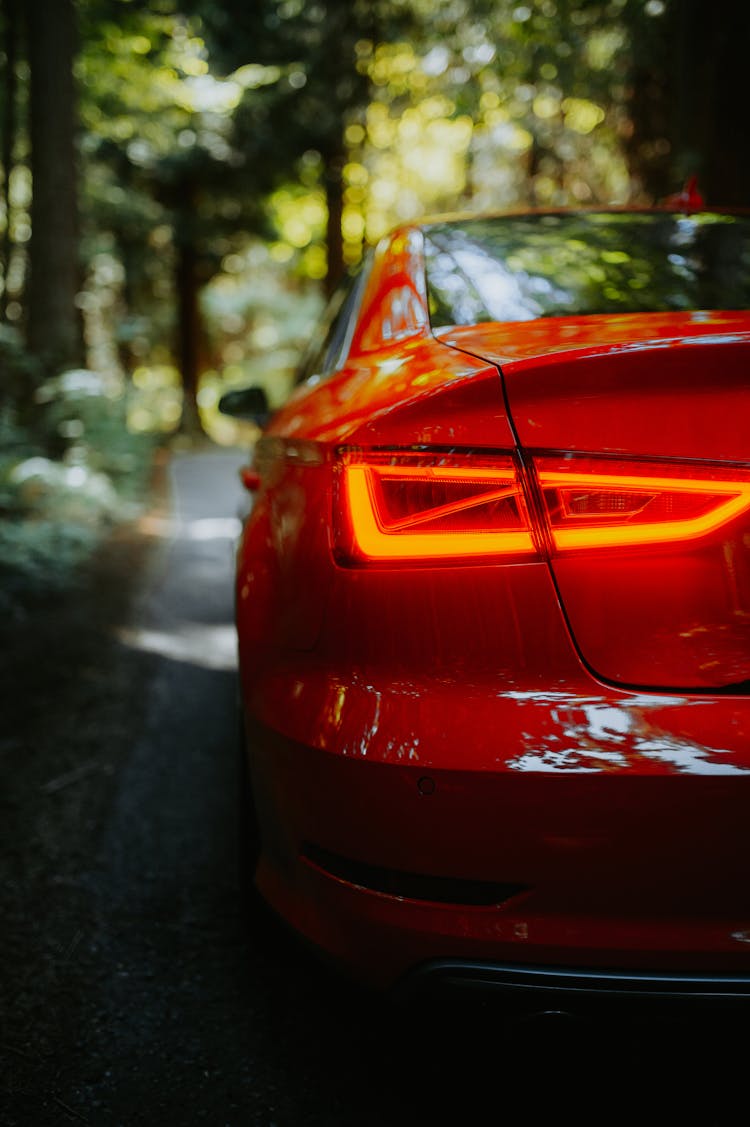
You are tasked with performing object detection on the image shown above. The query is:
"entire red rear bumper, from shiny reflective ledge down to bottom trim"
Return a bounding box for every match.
[245,622,750,996]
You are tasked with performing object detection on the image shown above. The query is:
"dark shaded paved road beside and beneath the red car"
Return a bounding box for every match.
[0,452,741,1127]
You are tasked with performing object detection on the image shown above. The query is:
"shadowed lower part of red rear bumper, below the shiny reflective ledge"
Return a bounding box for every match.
[244,726,750,997]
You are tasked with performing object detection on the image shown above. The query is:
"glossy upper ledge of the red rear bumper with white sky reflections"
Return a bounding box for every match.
[252,671,750,775]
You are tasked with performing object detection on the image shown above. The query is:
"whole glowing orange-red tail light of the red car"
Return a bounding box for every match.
[334,451,750,565]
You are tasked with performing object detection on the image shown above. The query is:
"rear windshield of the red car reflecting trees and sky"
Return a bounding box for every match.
[425,212,750,328]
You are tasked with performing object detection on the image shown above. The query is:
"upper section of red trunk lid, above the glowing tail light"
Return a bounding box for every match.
[443,312,750,462]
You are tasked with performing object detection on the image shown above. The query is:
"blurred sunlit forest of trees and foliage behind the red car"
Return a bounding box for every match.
[0,0,750,599]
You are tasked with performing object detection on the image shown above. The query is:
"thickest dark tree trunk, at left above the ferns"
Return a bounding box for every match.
[26,0,81,370]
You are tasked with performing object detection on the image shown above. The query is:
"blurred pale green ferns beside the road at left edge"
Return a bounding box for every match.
[0,330,151,613]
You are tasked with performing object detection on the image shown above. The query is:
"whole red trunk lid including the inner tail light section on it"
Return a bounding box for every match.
[441,312,750,692]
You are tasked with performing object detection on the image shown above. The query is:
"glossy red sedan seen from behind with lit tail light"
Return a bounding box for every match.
[228,207,750,997]
